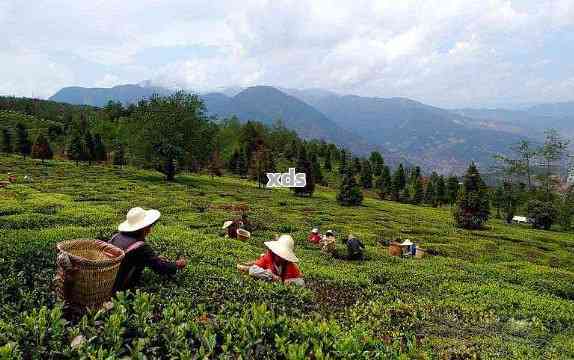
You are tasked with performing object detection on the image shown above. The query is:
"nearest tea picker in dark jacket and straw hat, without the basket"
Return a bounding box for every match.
[110,207,187,291]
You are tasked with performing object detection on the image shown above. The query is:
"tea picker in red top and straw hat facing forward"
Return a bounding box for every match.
[237,234,305,286]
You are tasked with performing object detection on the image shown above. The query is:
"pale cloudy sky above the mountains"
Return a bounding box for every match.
[0,0,574,107]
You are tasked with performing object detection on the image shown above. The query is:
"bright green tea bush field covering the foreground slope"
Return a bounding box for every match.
[0,156,574,359]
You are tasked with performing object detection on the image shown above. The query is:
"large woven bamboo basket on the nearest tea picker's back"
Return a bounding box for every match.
[56,239,124,307]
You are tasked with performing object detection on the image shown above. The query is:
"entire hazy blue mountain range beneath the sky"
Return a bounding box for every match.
[50,83,574,173]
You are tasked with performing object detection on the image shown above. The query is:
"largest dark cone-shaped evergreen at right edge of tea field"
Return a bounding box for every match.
[454,163,490,229]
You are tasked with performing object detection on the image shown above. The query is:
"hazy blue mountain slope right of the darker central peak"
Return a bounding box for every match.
[308,95,532,173]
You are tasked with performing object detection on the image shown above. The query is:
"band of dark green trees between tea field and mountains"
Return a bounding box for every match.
[0,92,574,229]
